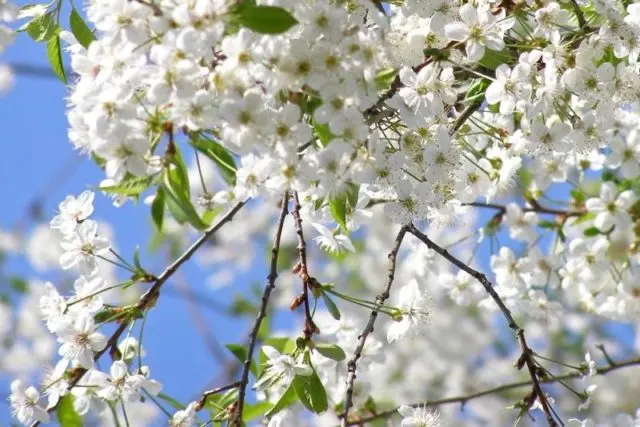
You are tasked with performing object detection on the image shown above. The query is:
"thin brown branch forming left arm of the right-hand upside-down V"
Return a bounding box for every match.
[341,225,409,427]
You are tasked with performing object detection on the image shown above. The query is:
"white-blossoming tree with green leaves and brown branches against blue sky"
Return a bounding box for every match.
[0,0,640,427]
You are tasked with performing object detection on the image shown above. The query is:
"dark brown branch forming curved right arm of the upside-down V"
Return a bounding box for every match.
[408,224,558,427]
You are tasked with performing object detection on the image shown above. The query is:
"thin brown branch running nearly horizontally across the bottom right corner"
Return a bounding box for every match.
[347,357,640,426]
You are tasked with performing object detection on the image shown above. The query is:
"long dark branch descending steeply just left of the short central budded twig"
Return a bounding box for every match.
[230,192,289,427]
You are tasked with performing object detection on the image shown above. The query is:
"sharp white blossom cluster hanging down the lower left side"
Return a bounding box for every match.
[9,191,161,424]
